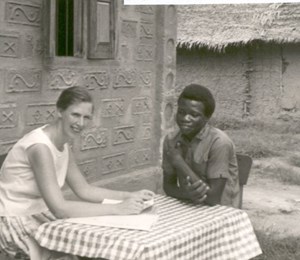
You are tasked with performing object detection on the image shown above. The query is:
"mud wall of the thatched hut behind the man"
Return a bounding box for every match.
[176,44,300,124]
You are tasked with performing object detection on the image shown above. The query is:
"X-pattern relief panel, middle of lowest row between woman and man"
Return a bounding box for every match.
[101,153,126,174]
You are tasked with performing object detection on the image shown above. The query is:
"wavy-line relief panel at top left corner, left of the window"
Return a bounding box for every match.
[5,1,41,26]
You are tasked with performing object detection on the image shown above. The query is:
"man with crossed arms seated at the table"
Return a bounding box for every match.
[162,84,239,207]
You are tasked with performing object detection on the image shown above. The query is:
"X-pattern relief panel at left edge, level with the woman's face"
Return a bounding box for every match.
[0,103,17,129]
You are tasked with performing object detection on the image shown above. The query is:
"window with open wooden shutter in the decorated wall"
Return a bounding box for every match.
[45,0,115,59]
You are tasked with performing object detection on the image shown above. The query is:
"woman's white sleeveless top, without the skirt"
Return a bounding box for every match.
[0,126,69,216]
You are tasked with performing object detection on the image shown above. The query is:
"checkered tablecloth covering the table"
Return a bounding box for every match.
[35,195,261,260]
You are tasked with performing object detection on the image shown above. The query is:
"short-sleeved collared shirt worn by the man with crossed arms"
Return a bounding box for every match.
[162,124,240,208]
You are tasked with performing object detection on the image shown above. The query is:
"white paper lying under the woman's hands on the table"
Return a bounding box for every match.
[65,199,158,231]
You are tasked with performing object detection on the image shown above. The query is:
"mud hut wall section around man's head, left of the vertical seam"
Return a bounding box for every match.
[176,48,248,120]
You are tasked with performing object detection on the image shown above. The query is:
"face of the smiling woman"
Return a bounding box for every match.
[59,102,93,138]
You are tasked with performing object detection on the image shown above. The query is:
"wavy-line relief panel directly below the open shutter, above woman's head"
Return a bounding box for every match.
[83,70,110,90]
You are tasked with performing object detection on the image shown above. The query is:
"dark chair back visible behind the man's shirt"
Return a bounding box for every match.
[236,154,252,209]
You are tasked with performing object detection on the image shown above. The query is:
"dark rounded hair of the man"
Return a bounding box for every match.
[178,84,216,118]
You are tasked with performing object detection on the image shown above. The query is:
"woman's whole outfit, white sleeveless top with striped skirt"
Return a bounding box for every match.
[0,126,69,259]
